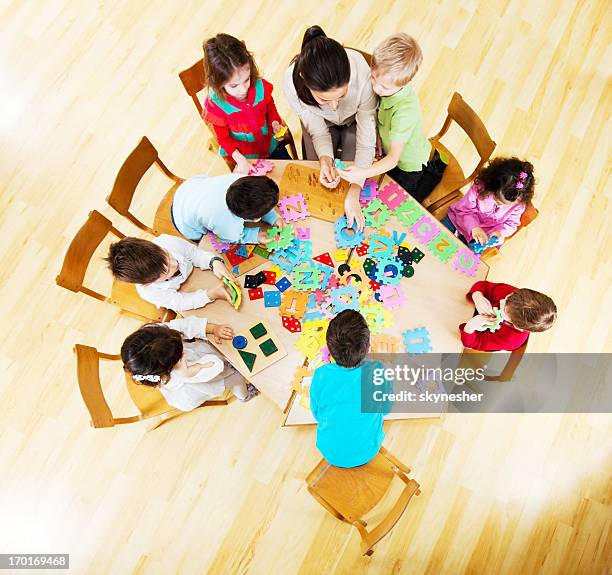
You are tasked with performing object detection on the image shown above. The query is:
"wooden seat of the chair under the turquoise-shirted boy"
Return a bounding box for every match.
[306,453,394,519]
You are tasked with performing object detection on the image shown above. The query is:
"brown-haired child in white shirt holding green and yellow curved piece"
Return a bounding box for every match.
[106,234,232,311]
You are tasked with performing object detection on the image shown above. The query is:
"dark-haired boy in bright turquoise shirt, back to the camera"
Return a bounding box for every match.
[310,310,385,467]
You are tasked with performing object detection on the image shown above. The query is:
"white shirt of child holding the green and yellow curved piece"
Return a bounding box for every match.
[136,234,215,311]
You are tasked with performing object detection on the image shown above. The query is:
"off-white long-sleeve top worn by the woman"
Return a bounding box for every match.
[283,49,378,168]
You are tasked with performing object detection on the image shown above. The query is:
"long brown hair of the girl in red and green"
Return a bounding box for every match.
[203,34,259,100]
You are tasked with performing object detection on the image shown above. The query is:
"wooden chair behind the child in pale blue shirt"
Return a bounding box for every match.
[106,136,184,236]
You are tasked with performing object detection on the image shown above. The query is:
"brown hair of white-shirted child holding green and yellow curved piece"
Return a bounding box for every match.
[104,238,168,284]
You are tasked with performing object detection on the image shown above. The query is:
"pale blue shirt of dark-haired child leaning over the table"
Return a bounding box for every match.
[172,174,279,244]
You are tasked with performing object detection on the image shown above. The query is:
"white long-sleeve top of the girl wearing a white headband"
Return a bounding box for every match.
[159,316,236,411]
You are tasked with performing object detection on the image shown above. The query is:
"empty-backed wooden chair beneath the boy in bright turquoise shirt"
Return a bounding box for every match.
[306,447,421,555]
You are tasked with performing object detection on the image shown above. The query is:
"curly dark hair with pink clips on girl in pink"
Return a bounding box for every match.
[475,158,535,204]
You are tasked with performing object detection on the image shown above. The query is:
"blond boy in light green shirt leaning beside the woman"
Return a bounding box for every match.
[340,34,446,202]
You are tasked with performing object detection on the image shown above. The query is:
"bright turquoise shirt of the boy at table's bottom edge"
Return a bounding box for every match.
[310,362,386,467]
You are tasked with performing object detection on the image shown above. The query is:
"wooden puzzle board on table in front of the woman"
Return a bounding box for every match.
[279,163,349,222]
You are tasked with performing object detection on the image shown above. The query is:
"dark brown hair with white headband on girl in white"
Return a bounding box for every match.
[121,324,183,387]
